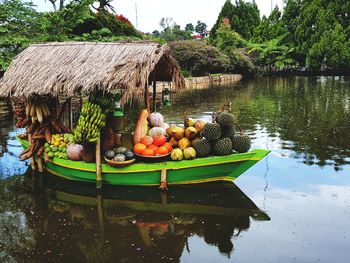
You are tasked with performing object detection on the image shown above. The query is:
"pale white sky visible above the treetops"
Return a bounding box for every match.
[32,0,283,33]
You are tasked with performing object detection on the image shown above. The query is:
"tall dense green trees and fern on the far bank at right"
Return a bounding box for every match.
[211,0,350,72]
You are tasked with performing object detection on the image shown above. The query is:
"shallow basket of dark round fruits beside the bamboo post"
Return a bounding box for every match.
[104,147,136,167]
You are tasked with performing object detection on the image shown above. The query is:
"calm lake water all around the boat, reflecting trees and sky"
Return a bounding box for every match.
[0,77,350,262]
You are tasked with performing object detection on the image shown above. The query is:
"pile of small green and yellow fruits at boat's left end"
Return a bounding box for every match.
[44,133,74,160]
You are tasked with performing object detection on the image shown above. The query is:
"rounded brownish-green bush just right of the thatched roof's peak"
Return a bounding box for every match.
[169,40,229,76]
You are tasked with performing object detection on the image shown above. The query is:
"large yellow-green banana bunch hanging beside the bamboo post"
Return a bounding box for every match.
[73,102,106,143]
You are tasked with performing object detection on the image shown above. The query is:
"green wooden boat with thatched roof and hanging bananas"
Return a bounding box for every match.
[0,42,269,189]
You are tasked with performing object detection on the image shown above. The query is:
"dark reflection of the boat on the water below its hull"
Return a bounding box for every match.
[0,174,270,262]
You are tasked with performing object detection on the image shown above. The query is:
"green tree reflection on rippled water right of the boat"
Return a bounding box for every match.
[165,77,350,170]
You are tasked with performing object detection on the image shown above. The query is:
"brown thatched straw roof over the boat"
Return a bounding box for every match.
[0,42,185,102]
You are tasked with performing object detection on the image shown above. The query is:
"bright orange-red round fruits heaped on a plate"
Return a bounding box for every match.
[134,135,173,160]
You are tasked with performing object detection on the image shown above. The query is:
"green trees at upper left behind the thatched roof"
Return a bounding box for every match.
[0,0,141,70]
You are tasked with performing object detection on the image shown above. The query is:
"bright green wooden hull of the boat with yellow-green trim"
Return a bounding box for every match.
[18,139,269,186]
